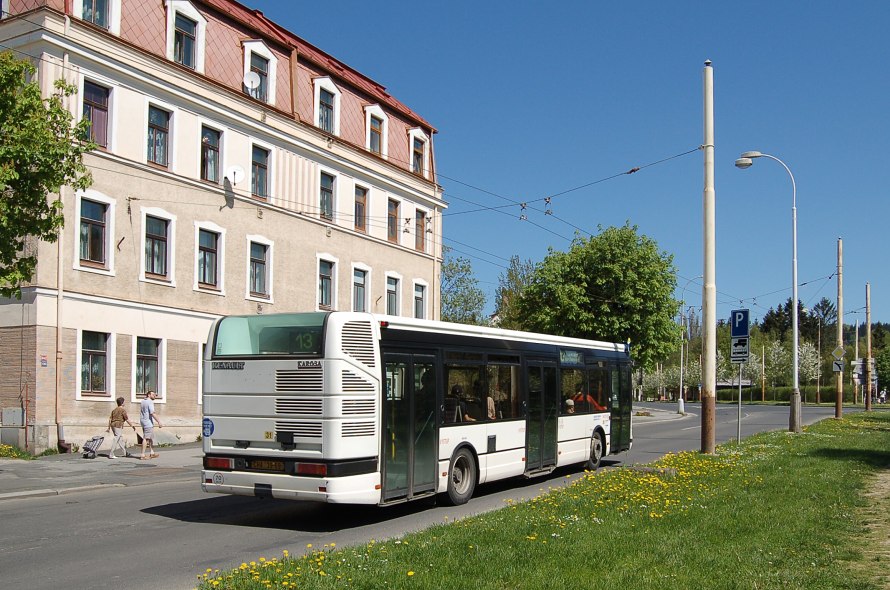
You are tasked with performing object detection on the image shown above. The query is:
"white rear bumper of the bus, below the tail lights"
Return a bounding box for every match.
[201,469,380,504]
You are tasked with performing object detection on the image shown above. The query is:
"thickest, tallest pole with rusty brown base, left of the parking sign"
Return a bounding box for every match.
[701,60,717,454]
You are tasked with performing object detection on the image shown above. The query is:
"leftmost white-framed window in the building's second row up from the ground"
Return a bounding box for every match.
[74,189,115,276]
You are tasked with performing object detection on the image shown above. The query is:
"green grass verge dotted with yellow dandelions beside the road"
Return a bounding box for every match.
[197,412,890,590]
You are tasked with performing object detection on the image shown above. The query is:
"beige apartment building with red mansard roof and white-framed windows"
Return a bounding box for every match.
[0,0,445,452]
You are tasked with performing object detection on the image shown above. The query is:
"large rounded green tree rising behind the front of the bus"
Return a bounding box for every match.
[518,224,680,368]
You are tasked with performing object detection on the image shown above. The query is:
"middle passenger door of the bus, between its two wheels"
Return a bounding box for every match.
[525,361,559,472]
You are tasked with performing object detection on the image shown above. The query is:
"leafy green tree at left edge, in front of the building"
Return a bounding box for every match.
[0,51,95,297]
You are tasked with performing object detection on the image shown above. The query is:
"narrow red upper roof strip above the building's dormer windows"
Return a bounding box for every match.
[199,0,436,133]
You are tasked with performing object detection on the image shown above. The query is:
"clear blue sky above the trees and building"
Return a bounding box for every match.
[244,0,890,324]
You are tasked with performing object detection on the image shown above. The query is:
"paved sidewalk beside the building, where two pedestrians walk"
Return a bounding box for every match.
[0,438,204,502]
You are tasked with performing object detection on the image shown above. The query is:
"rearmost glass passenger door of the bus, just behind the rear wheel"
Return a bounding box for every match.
[381,353,438,501]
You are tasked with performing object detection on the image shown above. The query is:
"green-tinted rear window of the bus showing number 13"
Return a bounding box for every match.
[213,312,327,358]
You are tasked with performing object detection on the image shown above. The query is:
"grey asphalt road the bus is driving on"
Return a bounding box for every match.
[0,404,833,590]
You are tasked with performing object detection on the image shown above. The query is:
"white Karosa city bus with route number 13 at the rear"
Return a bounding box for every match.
[202,312,631,504]
